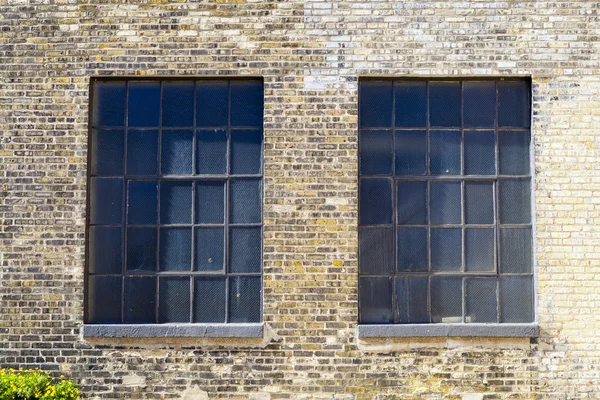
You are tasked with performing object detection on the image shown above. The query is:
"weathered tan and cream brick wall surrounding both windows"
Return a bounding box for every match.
[0,0,600,400]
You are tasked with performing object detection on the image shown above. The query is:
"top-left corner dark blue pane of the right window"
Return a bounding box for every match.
[358,81,393,128]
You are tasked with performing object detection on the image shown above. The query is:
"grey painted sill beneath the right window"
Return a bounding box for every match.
[358,323,540,338]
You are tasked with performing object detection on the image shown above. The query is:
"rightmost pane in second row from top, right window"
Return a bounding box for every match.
[498,131,531,175]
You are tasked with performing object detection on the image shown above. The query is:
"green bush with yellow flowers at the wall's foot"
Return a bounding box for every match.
[0,368,79,400]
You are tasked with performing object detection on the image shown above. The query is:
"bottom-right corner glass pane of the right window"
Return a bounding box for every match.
[500,276,533,322]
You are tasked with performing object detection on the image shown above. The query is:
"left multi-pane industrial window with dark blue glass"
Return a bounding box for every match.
[86,79,263,324]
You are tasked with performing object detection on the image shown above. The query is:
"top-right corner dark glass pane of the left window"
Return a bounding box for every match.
[231,81,263,127]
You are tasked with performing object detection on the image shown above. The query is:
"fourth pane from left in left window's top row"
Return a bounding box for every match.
[196,81,229,127]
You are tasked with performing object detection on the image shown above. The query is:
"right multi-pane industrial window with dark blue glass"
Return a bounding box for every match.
[359,79,534,324]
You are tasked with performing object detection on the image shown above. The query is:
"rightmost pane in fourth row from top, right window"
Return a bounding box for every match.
[500,228,531,274]
